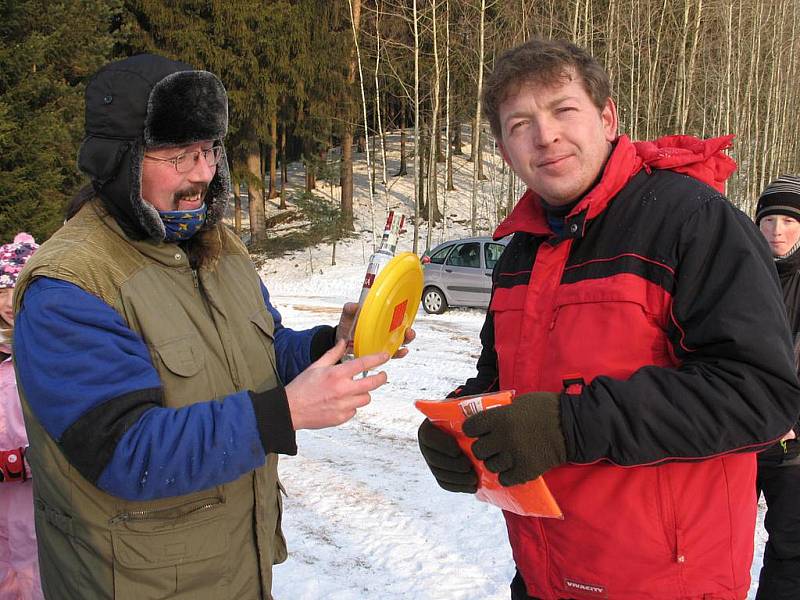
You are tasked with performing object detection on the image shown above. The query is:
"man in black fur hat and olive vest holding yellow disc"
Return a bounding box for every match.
[10,55,400,600]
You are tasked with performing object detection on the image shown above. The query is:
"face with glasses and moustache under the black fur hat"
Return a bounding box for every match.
[142,141,217,211]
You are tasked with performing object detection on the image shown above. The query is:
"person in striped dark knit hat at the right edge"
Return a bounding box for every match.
[756,175,800,600]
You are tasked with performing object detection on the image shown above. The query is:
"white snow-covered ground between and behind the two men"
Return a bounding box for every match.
[241,136,765,600]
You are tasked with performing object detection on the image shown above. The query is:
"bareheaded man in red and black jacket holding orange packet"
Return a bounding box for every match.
[419,40,800,600]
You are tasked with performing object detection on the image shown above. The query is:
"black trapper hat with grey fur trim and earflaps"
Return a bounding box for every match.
[78,54,230,242]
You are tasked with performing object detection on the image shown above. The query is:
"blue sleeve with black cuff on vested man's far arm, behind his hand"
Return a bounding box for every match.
[261,282,336,383]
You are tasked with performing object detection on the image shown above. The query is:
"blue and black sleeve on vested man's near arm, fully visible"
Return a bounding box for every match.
[14,278,284,500]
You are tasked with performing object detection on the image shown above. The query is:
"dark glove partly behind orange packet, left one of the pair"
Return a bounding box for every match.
[417,419,478,494]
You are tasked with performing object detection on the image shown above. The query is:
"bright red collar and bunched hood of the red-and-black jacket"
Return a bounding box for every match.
[493,135,736,239]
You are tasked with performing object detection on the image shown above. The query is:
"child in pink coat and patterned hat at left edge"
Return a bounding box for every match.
[0,233,43,600]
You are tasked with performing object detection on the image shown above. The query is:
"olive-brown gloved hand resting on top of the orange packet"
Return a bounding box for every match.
[464,392,567,486]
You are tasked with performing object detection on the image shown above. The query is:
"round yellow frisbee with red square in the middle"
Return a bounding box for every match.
[353,252,423,356]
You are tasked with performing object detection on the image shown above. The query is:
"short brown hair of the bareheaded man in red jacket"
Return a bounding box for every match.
[482,38,611,139]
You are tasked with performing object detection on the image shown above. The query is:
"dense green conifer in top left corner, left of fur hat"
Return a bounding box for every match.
[0,0,120,241]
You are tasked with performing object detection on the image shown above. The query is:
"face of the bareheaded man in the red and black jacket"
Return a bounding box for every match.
[499,71,617,206]
